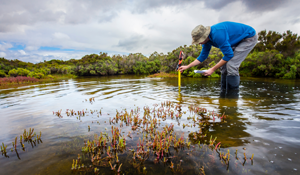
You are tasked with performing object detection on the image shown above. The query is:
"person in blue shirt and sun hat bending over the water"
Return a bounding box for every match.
[179,21,257,92]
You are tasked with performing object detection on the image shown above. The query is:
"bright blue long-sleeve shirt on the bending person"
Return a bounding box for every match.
[197,21,256,62]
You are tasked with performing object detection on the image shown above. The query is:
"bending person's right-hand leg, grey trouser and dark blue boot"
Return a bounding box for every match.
[226,35,257,91]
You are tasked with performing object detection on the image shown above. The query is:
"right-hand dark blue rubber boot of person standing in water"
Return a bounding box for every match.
[226,76,240,98]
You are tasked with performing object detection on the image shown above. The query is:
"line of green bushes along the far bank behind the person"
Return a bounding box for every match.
[0,30,300,79]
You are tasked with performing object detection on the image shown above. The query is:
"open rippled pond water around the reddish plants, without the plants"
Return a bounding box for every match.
[0,76,300,174]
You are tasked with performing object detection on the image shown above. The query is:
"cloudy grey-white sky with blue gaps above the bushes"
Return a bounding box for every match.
[0,0,300,63]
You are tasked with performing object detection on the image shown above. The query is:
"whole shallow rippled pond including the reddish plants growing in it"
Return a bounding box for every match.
[0,75,300,174]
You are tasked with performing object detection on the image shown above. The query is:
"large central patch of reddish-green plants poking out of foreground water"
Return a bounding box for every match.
[49,98,254,174]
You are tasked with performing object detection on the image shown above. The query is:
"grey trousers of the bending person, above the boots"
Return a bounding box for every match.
[221,34,257,76]
